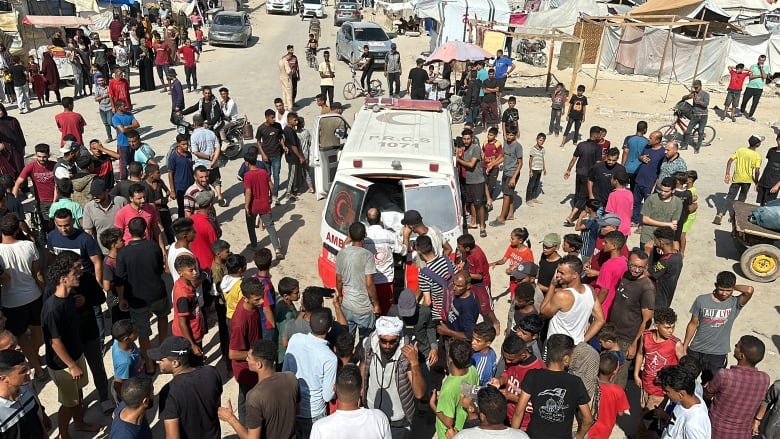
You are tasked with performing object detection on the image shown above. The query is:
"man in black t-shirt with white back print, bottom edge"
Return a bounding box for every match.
[512,334,593,439]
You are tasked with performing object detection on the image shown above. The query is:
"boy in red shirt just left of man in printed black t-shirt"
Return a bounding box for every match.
[489,333,544,430]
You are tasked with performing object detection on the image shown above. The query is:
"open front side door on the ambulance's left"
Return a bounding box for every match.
[311,113,349,200]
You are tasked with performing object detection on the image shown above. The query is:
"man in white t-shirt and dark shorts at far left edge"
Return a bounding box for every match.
[0,212,43,378]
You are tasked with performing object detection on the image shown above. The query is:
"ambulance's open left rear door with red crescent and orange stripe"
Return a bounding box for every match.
[317,175,372,288]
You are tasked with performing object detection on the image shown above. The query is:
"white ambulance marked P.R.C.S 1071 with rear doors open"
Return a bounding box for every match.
[311,99,463,288]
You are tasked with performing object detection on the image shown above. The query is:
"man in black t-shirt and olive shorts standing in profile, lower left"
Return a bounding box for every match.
[41,255,100,439]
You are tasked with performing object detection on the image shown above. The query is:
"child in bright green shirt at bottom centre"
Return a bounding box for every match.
[430,340,479,439]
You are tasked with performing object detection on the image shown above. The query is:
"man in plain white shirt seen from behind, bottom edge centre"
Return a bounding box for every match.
[311,364,392,439]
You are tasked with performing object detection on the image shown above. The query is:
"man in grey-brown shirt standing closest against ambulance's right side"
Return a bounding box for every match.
[456,129,487,238]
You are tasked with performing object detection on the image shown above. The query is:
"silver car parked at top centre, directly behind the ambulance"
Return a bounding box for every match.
[336,22,391,68]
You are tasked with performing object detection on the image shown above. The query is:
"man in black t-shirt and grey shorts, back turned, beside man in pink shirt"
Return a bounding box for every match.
[114,217,170,373]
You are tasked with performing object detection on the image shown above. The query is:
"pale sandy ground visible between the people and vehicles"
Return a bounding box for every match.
[15,0,780,438]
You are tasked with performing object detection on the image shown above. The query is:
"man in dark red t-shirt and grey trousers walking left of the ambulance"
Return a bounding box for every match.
[244,152,284,259]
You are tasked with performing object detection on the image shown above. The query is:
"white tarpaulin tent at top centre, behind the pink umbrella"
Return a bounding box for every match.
[414,0,511,47]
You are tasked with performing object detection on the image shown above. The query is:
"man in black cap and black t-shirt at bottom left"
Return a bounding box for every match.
[154,337,222,439]
